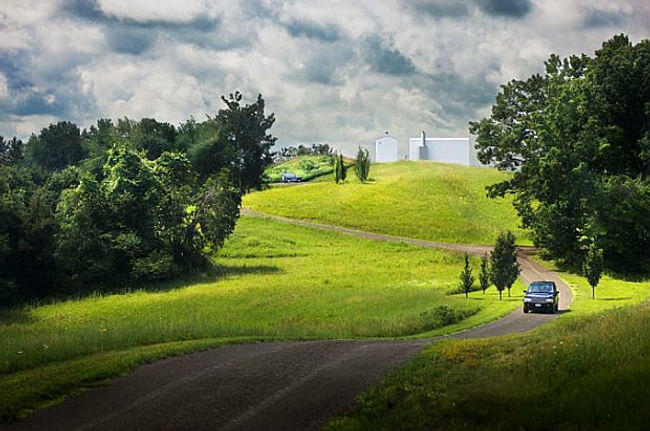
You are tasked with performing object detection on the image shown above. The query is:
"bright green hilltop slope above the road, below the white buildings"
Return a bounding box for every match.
[244,162,530,244]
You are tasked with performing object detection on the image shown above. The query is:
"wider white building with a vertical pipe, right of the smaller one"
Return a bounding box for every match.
[409,132,471,166]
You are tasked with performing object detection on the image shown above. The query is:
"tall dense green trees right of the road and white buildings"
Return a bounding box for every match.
[470,35,650,273]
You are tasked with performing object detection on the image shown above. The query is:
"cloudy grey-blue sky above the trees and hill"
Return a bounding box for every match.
[0,0,650,154]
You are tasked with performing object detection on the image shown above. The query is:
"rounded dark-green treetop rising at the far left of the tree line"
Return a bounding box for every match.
[25,121,86,171]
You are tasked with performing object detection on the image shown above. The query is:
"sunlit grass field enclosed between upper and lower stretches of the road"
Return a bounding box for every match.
[0,217,523,421]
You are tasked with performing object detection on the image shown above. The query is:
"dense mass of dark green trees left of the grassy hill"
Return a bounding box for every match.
[0,93,275,306]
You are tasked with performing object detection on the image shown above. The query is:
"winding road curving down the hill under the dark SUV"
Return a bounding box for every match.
[7,209,572,431]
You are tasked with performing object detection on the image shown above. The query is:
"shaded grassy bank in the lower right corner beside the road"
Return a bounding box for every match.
[326,300,650,431]
